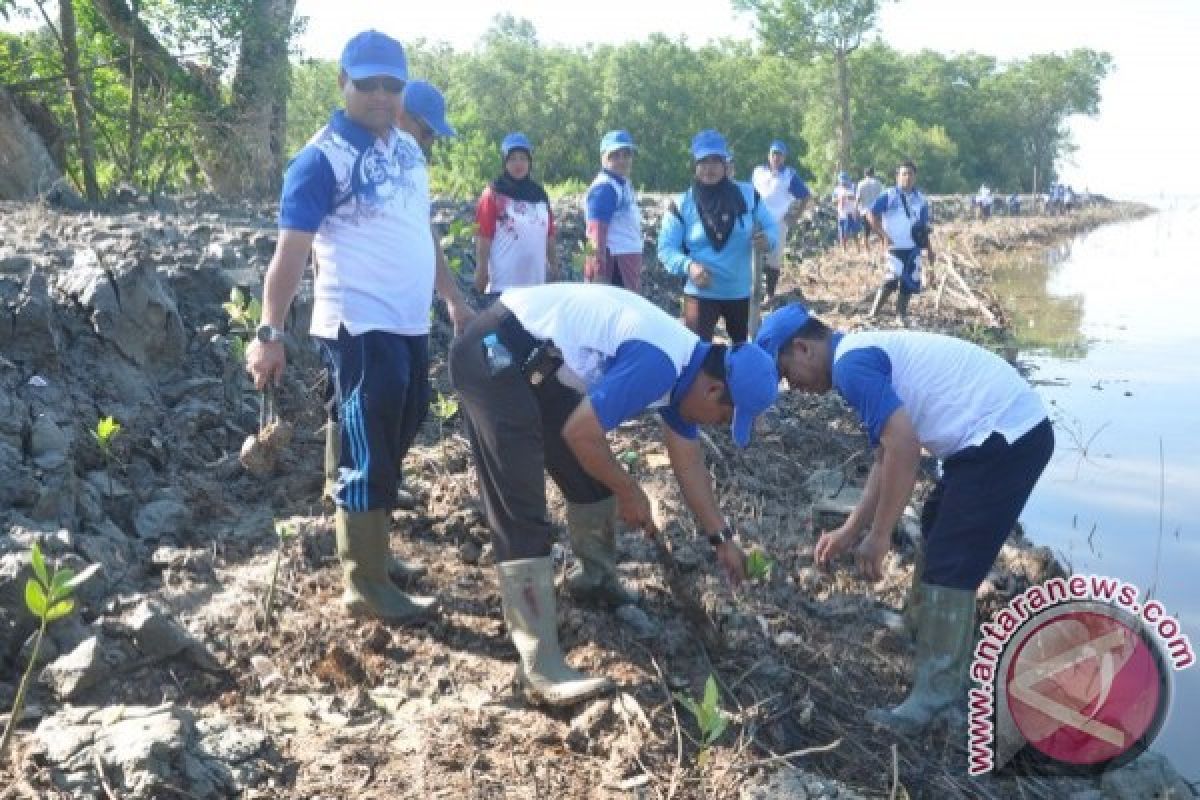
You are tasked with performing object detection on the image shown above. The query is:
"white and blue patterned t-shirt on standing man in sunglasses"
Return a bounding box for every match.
[280,110,436,338]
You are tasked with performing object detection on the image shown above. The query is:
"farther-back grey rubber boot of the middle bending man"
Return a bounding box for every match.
[566,498,637,608]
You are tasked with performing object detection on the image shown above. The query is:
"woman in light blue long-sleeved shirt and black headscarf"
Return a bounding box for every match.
[659,130,779,344]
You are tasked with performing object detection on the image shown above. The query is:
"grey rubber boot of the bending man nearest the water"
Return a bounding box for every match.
[866,583,976,735]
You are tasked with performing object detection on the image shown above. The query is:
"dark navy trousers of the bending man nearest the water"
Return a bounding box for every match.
[920,420,1054,589]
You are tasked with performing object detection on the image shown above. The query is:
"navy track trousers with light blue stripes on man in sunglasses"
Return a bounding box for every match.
[313,327,430,512]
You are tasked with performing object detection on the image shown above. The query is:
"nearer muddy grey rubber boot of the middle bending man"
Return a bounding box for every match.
[496,555,613,706]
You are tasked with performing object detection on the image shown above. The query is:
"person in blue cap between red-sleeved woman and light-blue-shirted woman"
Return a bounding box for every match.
[583,131,644,291]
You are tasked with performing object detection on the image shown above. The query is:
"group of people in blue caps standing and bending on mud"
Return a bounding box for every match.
[246,31,1052,743]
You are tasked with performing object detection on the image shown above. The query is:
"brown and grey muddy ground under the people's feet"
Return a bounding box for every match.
[0,199,1178,799]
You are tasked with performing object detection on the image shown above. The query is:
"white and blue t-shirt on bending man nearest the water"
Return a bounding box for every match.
[830,331,1046,459]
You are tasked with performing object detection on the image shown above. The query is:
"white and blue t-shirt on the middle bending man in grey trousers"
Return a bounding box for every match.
[500,283,710,439]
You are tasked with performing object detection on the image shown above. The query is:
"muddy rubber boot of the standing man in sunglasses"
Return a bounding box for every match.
[334,509,437,622]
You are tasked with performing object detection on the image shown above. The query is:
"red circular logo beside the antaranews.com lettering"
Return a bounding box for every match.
[1004,609,1168,766]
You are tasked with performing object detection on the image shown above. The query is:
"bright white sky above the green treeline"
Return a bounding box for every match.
[296,0,1200,198]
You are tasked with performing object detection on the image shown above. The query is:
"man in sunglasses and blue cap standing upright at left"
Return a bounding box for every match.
[246,30,472,621]
